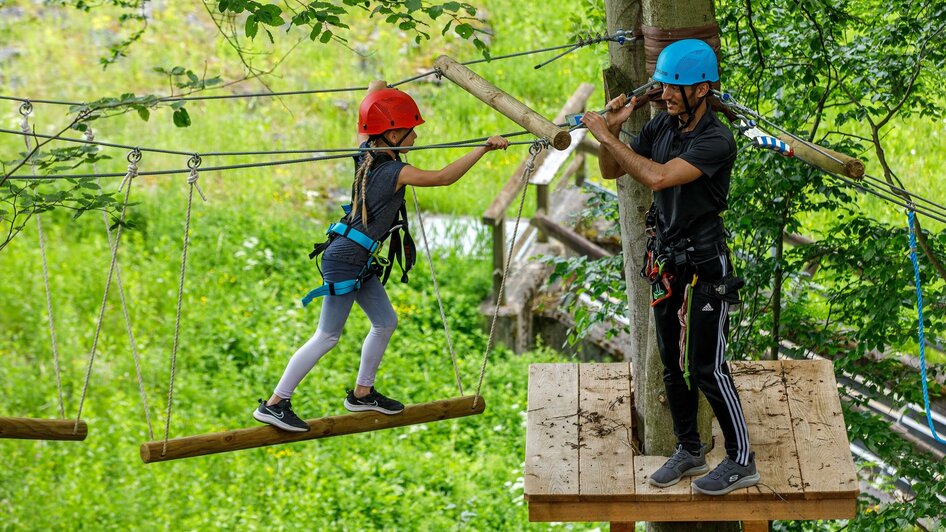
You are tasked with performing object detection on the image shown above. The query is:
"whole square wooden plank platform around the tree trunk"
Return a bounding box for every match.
[524,360,858,523]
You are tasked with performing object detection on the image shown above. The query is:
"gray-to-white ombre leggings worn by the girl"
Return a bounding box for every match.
[275,259,397,399]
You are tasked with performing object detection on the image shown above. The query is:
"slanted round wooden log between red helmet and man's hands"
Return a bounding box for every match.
[434,55,572,150]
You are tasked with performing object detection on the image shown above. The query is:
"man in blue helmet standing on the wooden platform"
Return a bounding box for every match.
[582,39,759,495]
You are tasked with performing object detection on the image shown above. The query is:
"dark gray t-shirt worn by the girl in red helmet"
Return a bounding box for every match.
[323,144,407,266]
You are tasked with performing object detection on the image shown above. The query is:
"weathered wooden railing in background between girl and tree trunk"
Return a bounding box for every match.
[483,83,595,304]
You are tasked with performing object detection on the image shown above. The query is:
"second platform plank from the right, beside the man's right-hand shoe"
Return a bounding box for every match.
[732,361,804,500]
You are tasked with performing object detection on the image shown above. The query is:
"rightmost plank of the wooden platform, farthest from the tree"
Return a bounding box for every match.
[782,360,859,499]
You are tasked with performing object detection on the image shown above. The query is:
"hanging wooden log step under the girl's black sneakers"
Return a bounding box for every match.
[141,395,486,464]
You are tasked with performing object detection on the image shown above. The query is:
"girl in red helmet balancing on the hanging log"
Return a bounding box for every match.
[253,80,509,432]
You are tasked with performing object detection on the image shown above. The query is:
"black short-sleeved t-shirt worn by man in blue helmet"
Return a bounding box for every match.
[630,111,736,244]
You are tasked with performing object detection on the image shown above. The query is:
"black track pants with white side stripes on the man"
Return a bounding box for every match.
[654,255,749,465]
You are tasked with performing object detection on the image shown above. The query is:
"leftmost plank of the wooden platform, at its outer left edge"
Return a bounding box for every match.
[524,364,579,501]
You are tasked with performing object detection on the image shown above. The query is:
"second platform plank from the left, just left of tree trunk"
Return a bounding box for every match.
[578,362,634,500]
